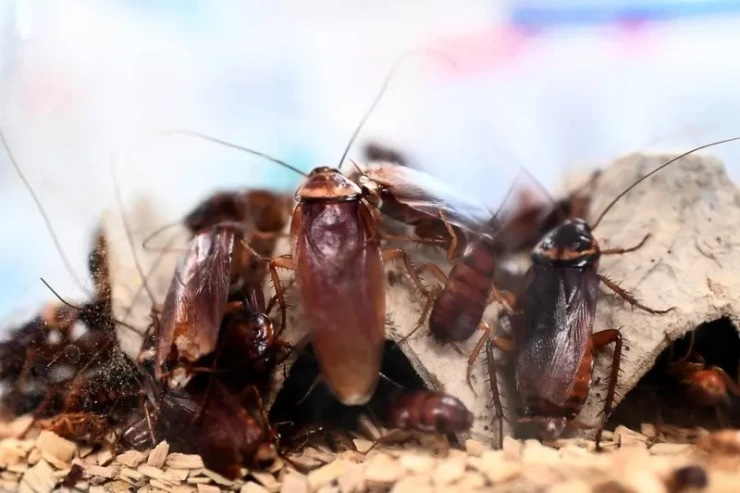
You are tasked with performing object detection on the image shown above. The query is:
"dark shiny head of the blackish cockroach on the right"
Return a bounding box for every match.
[532,218,601,267]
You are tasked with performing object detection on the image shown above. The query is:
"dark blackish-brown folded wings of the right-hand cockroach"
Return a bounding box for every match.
[514,265,599,405]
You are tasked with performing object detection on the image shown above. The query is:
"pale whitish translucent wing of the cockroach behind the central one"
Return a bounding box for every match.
[365,166,493,232]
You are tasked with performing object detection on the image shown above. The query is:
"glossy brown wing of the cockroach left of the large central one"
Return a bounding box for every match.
[155,229,235,378]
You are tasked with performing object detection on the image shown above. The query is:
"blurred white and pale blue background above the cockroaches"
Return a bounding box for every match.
[0,0,740,319]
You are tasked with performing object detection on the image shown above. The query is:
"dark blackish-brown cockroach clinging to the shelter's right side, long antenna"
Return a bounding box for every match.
[480,137,740,446]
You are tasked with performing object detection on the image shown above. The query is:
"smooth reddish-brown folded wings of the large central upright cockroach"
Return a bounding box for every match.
[292,201,385,405]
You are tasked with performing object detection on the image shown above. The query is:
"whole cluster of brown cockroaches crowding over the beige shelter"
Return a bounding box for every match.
[0,57,740,476]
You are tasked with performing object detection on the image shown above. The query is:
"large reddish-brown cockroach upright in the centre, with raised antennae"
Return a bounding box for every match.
[155,51,462,405]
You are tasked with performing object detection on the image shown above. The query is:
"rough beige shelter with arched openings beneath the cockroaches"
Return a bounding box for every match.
[111,150,740,446]
